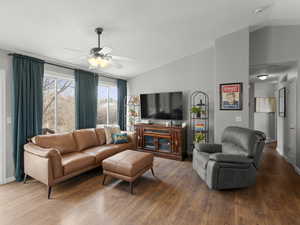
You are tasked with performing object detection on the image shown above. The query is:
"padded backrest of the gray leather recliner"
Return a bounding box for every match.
[222,127,258,157]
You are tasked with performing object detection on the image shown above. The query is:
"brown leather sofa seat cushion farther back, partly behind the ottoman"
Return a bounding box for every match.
[83,143,132,163]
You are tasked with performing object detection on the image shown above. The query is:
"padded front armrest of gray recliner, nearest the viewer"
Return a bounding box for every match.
[209,153,253,164]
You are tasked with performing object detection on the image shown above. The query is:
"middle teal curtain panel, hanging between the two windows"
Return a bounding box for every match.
[75,70,98,129]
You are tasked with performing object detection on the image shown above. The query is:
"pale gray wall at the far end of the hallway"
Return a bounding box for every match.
[252,82,277,140]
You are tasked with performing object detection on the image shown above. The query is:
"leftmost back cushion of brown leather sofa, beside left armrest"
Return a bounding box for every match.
[32,132,78,154]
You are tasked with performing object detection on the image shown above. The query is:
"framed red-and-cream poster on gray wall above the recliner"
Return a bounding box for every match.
[220,83,243,110]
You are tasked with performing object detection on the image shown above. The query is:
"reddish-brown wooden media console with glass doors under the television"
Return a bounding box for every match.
[134,123,186,160]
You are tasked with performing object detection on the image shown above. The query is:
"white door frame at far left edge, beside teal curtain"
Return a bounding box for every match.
[0,70,6,184]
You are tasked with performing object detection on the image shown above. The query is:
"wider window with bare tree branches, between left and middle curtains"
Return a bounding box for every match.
[43,76,75,133]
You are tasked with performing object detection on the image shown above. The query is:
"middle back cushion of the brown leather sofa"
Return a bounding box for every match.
[73,129,99,151]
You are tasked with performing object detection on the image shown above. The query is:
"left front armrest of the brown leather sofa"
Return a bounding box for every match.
[24,143,63,183]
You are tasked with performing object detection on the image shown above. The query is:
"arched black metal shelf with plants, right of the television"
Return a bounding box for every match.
[190,91,209,147]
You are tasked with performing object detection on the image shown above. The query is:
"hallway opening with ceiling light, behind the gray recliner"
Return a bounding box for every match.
[249,62,298,165]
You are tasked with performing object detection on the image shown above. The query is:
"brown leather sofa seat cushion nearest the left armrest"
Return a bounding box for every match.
[62,152,96,175]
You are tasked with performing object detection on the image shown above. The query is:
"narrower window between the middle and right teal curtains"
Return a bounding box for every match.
[97,84,118,125]
